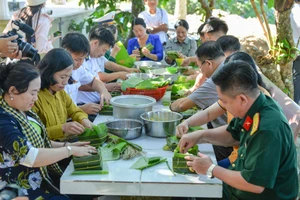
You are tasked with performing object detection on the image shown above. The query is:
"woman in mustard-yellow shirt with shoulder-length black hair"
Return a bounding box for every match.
[33,48,92,142]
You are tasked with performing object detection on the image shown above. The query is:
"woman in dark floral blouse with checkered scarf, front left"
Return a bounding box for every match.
[0,62,96,200]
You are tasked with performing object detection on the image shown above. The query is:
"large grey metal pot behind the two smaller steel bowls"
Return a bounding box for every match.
[110,95,156,120]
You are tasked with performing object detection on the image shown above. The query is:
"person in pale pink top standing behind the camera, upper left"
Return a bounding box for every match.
[3,0,58,54]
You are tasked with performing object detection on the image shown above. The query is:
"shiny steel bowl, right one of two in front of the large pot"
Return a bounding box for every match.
[141,111,182,138]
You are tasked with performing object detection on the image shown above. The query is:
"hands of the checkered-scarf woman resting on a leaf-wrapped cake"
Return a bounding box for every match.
[67,142,97,157]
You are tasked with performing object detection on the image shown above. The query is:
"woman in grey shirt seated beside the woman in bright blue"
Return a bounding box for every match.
[165,19,197,64]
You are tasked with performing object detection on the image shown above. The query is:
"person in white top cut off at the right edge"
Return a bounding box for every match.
[290,0,300,104]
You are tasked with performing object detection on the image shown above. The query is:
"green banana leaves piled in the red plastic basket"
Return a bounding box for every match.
[121,76,170,91]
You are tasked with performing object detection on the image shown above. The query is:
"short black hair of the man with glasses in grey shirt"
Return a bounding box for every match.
[196,41,225,61]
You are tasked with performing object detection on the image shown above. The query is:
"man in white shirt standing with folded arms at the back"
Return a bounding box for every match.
[138,0,169,44]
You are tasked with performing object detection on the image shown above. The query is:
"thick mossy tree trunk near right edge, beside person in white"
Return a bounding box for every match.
[275,3,295,99]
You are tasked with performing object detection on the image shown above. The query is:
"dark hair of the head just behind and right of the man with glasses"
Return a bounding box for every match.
[217,35,241,52]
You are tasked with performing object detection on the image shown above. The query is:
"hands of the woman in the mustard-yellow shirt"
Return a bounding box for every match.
[62,119,93,135]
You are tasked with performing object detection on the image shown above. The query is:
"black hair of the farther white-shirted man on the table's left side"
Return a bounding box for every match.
[89,24,115,47]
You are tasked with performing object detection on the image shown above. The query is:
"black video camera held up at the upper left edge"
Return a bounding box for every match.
[0,20,40,62]
